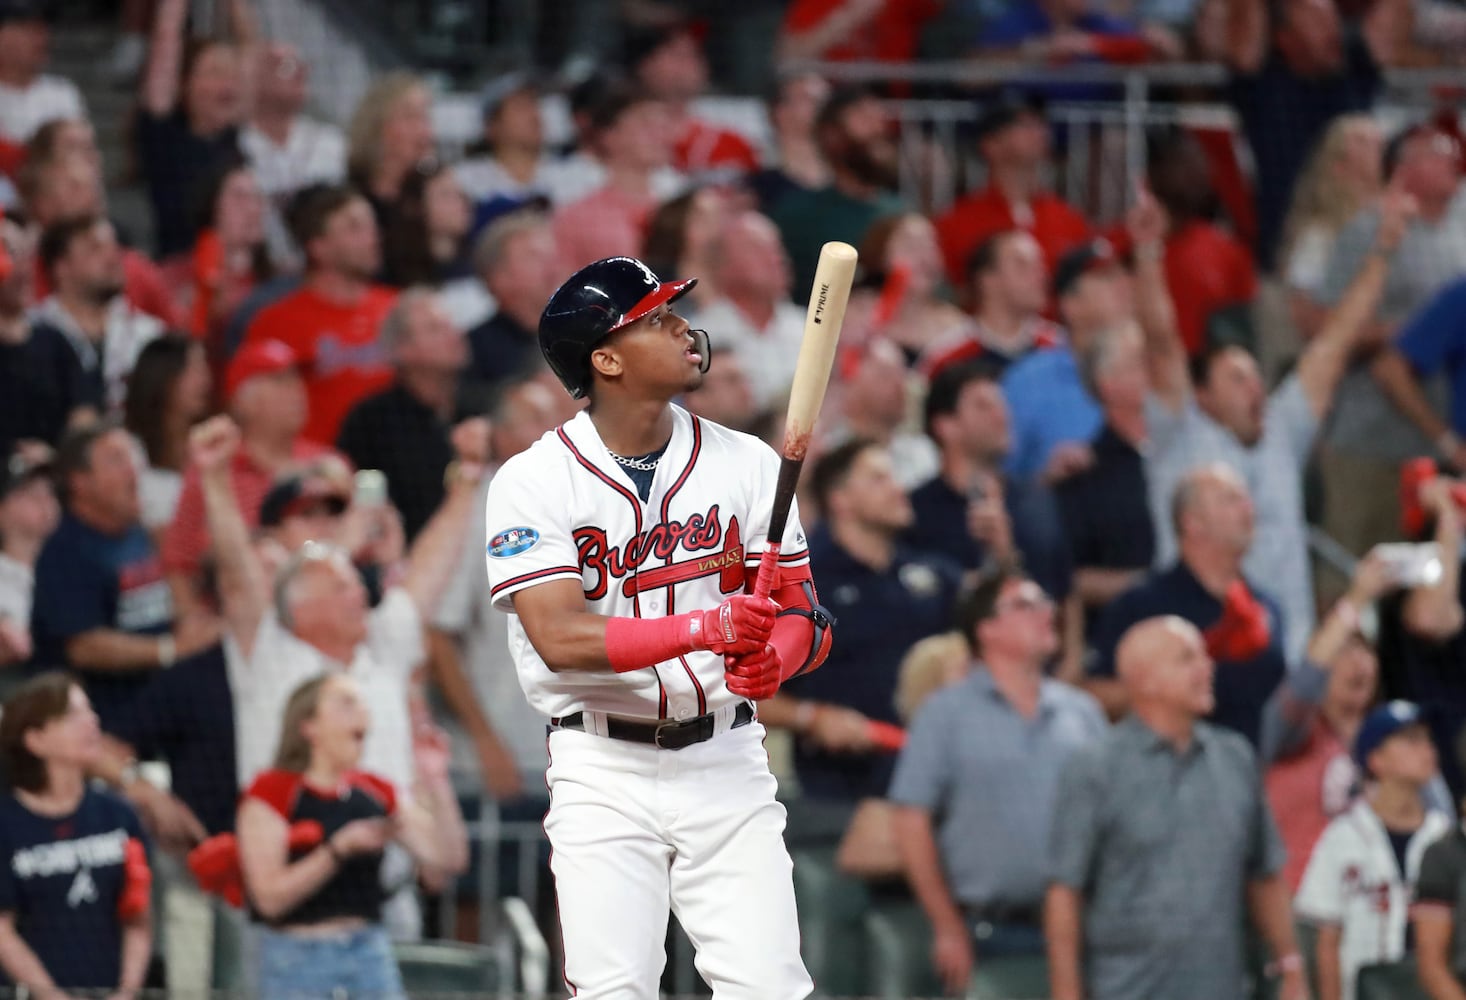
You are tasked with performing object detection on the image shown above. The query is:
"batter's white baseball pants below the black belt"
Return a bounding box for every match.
[545,712,814,1000]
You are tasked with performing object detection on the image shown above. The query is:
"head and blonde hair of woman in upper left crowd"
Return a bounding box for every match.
[346,70,432,229]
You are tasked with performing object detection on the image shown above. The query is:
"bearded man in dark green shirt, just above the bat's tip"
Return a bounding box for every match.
[773,88,902,297]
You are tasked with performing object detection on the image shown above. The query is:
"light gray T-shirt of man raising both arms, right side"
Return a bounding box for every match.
[1145,375,1318,664]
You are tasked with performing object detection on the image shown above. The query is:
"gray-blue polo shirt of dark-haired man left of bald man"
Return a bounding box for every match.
[890,666,1107,908]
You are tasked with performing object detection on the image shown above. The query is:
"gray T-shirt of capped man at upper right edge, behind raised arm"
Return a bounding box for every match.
[1319,188,1466,462]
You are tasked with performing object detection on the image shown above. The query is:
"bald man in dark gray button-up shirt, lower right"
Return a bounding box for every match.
[1044,617,1308,1000]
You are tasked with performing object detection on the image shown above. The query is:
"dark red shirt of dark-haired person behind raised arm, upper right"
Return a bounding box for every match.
[1110,221,1258,355]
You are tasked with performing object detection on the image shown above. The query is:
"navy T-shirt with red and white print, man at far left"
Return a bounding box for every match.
[31,513,173,730]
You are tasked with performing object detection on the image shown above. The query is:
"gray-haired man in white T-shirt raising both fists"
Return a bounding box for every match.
[189,416,488,938]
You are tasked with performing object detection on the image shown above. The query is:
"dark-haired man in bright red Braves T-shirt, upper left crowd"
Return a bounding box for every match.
[245,185,396,444]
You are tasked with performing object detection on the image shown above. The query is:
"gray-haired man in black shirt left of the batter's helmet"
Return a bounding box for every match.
[336,287,469,541]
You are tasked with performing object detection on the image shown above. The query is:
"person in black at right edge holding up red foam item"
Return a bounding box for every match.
[1380,463,1466,801]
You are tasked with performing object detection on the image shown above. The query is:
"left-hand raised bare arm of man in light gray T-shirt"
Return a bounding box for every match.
[1126,186,1190,412]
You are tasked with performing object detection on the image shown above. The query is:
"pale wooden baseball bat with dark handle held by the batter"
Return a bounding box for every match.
[754,242,858,597]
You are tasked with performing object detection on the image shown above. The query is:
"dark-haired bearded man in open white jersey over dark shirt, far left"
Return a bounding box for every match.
[35,216,163,409]
